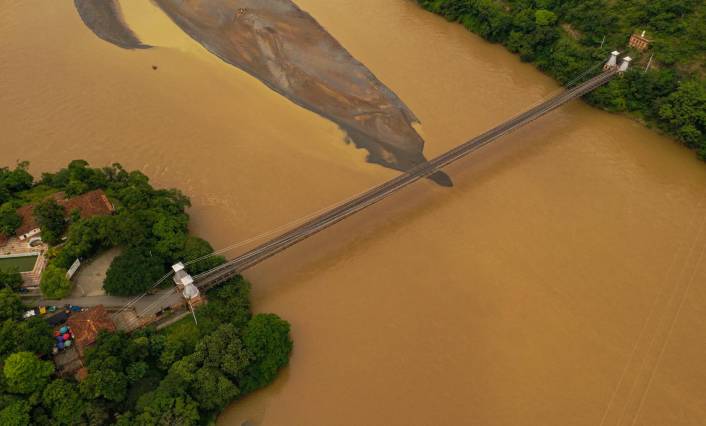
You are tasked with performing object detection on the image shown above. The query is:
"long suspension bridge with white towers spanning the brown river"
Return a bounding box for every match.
[125,51,620,318]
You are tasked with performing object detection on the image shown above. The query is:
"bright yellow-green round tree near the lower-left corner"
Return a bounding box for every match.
[3,352,54,394]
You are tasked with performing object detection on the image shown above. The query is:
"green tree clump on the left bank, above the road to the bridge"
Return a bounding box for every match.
[31,160,225,296]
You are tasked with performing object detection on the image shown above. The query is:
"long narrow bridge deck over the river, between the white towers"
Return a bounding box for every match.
[194,70,617,290]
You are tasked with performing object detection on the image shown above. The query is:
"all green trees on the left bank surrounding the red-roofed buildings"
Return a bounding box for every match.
[0,160,293,426]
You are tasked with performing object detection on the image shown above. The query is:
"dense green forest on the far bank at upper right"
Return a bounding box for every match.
[417,0,706,160]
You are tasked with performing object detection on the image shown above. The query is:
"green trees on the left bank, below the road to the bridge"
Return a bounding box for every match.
[0,277,292,425]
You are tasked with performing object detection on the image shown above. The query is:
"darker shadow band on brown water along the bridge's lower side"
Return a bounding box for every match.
[244,111,573,303]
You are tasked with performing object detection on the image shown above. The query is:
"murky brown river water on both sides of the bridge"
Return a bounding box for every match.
[0,0,706,426]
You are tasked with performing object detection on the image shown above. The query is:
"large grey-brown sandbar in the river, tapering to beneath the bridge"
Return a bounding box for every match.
[155,0,452,186]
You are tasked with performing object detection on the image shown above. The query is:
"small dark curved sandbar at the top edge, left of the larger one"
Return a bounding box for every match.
[74,0,150,49]
